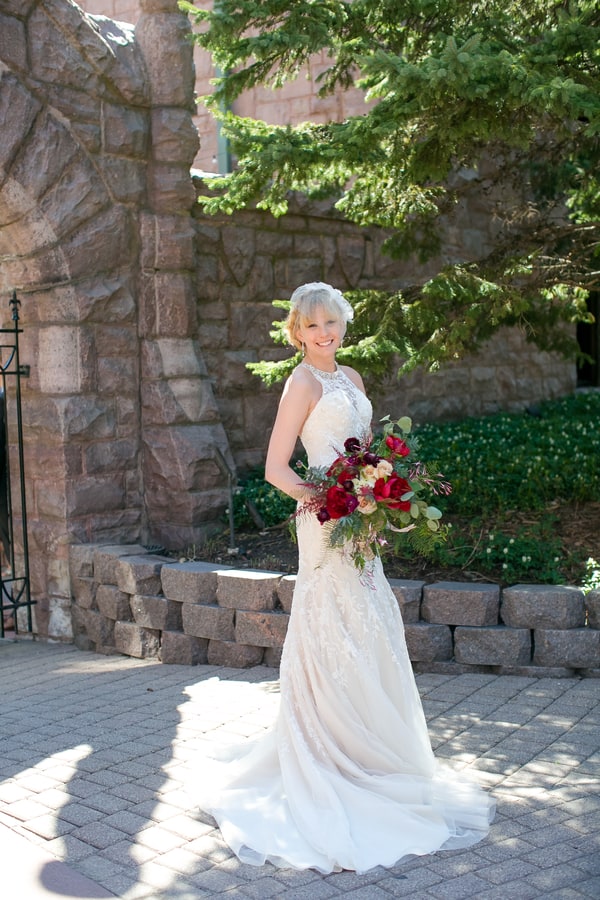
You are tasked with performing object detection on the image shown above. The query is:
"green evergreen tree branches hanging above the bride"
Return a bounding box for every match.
[180,0,600,380]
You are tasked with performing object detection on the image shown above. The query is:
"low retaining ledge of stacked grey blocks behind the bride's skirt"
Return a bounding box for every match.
[69,544,600,676]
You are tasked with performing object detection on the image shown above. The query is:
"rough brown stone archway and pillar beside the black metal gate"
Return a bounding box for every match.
[0,0,229,637]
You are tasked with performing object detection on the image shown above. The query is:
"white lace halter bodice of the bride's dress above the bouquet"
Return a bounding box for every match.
[300,363,373,466]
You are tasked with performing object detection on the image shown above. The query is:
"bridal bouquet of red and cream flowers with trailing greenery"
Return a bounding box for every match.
[301,416,452,571]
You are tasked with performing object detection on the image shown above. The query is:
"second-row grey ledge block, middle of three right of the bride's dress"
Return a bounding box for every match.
[454,625,531,666]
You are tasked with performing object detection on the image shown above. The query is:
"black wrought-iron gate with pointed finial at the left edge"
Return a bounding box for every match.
[0,291,36,637]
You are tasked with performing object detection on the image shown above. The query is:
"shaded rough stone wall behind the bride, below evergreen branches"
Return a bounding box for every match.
[194,190,576,469]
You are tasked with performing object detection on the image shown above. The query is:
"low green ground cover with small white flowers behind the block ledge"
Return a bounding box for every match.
[202,391,600,588]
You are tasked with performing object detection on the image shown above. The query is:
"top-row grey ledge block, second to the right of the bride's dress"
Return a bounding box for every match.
[421,581,500,625]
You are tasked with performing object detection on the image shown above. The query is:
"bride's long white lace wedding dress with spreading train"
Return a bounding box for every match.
[195,367,494,873]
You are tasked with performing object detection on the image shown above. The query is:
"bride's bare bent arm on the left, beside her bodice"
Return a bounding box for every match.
[265,373,320,500]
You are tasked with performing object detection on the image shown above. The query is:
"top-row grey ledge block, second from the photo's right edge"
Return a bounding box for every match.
[500,584,585,630]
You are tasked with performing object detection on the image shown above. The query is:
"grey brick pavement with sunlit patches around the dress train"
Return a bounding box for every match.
[0,638,600,900]
